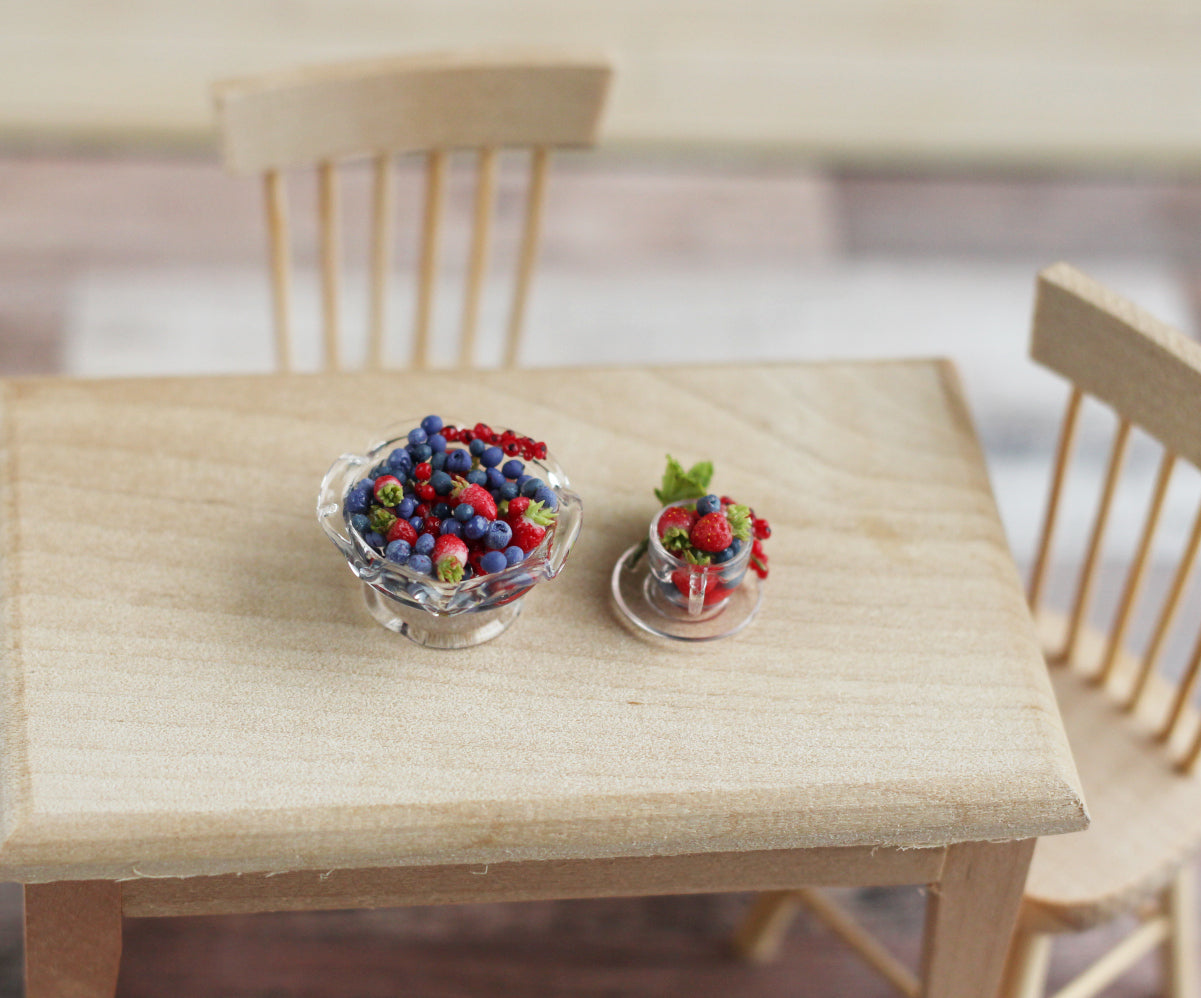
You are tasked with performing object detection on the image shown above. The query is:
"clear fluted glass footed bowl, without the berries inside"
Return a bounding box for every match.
[317,419,582,649]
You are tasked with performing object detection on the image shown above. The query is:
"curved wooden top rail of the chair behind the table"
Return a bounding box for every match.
[214,50,611,173]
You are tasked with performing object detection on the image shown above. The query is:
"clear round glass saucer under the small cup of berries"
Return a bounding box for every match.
[610,544,763,641]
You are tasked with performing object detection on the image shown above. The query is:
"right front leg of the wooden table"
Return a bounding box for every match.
[922,838,1034,998]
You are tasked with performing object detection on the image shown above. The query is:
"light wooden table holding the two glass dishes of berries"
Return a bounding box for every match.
[0,361,1087,998]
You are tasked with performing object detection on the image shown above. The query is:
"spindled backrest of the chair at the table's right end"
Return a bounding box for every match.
[1029,263,1201,771]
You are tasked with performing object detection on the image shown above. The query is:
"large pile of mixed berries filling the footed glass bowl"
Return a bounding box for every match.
[343,416,558,582]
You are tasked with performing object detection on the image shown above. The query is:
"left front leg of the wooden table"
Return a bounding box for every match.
[25,880,121,998]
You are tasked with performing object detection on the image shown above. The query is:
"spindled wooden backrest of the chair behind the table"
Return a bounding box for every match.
[214,53,611,370]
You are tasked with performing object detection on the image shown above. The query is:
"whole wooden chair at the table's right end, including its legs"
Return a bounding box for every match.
[735,264,1201,998]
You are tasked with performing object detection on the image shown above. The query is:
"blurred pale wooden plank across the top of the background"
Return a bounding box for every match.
[7,0,1201,167]
